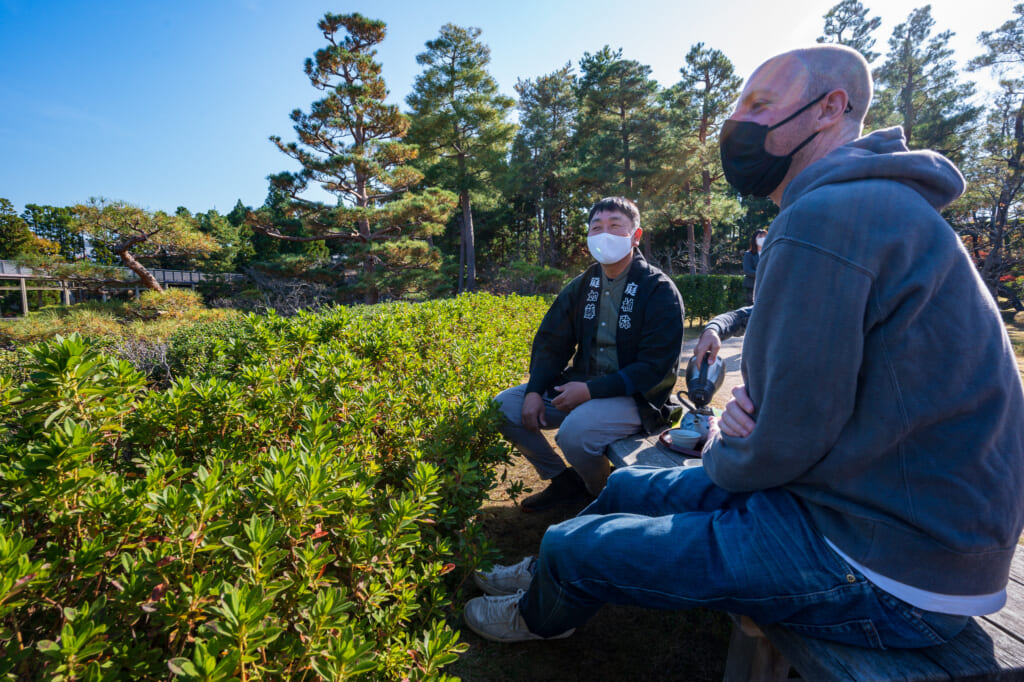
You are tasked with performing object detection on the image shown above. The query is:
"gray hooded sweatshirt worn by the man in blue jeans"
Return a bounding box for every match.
[705,128,1024,595]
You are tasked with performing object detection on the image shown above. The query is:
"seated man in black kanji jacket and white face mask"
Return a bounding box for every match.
[496,197,683,511]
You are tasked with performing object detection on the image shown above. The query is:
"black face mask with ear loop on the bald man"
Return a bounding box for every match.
[718,92,828,197]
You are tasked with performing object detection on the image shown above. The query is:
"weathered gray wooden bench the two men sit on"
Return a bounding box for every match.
[606,436,1024,682]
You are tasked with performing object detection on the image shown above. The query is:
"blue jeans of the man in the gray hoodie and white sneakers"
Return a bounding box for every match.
[519,467,968,648]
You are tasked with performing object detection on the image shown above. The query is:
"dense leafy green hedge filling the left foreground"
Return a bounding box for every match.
[0,294,547,680]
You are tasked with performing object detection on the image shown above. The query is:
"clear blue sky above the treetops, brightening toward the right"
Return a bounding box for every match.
[0,0,1013,213]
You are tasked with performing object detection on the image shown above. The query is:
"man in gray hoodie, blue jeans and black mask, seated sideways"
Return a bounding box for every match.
[466,45,1024,647]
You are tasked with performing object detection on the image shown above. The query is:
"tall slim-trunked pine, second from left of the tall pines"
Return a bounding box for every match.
[406,24,515,292]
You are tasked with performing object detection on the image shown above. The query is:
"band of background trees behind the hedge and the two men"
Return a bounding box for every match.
[0,0,1024,312]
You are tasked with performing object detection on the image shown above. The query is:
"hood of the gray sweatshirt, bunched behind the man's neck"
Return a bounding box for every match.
[779,126,967,211]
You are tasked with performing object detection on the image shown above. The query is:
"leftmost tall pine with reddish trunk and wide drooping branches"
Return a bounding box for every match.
[247,13,455,303]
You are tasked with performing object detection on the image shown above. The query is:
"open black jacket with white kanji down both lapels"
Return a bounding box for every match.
[526,251,685,432]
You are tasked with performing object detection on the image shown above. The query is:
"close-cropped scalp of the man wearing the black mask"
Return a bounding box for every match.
[758,45,872,137]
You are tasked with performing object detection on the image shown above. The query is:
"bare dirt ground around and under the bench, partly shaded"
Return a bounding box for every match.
[445,366,738,682]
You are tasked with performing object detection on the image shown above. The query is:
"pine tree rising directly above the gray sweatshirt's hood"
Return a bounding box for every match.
[867,5,981,161]
